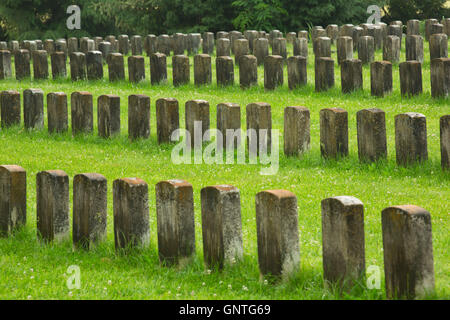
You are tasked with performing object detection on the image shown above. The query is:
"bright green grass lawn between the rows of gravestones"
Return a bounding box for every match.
[0,43,450,299]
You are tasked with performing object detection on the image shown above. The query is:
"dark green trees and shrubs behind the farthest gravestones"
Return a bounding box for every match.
[0,0,450,40]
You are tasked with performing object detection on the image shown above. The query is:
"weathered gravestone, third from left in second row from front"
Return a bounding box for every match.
[47,92,68,133]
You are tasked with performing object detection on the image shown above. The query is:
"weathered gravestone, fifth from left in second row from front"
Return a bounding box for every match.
[97,94,120,138]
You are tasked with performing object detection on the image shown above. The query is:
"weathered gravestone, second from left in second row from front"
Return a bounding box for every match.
[23,89,44,130]
